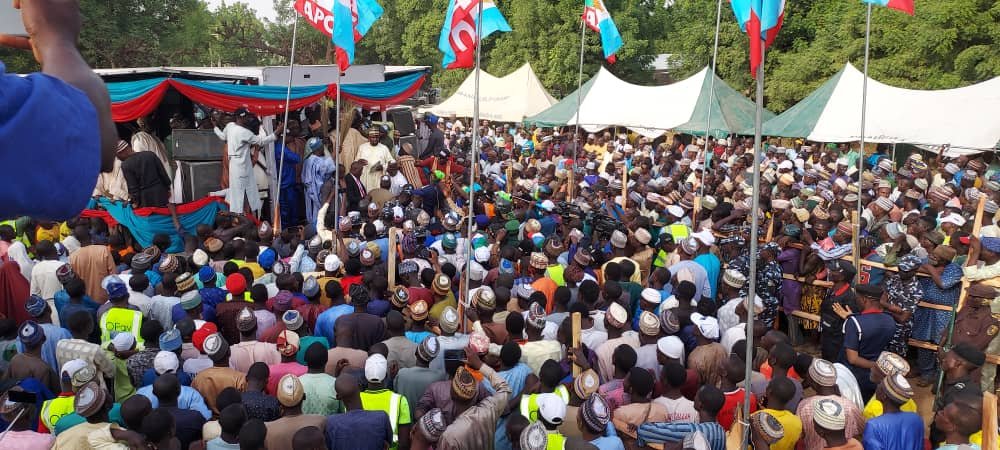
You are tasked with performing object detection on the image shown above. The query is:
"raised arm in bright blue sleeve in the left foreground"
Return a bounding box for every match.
[0,0,118,220]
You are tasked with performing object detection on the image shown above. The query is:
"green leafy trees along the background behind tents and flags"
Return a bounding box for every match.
[0,0,1000,111]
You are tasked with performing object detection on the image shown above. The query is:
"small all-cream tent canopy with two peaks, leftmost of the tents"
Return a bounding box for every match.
[427,64,556,122]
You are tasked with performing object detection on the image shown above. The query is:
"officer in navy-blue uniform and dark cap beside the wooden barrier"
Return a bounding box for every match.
[833,284,896,398]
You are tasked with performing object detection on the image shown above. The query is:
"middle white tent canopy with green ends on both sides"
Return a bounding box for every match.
[526,67,774,137]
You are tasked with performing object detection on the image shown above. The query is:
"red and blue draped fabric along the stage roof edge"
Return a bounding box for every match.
[106,72,427,122]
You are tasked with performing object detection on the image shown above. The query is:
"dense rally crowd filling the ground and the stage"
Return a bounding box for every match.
[0,104,1000,450]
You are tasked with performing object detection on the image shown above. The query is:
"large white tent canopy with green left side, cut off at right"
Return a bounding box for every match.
[763,63,1000,153]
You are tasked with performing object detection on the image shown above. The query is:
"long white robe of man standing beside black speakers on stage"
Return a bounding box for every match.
[215,122,277,213]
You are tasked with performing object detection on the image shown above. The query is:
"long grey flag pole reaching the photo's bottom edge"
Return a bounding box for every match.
[743,40,767,448]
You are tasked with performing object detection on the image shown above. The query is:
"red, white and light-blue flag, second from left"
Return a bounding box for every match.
[438,0,510,69]
